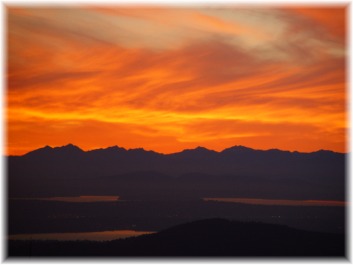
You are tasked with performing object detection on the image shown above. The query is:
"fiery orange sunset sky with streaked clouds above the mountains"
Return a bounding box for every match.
[6,6,348,155]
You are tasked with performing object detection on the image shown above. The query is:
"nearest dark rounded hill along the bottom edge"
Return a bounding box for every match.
[9,219,345,257]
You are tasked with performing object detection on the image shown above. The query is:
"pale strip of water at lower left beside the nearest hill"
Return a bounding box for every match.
[9,230,154,241]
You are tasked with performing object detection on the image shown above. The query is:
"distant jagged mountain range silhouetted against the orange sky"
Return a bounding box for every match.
[7,144,346,200]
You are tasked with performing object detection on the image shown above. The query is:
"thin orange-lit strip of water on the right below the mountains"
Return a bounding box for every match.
[204,198,346,207]
